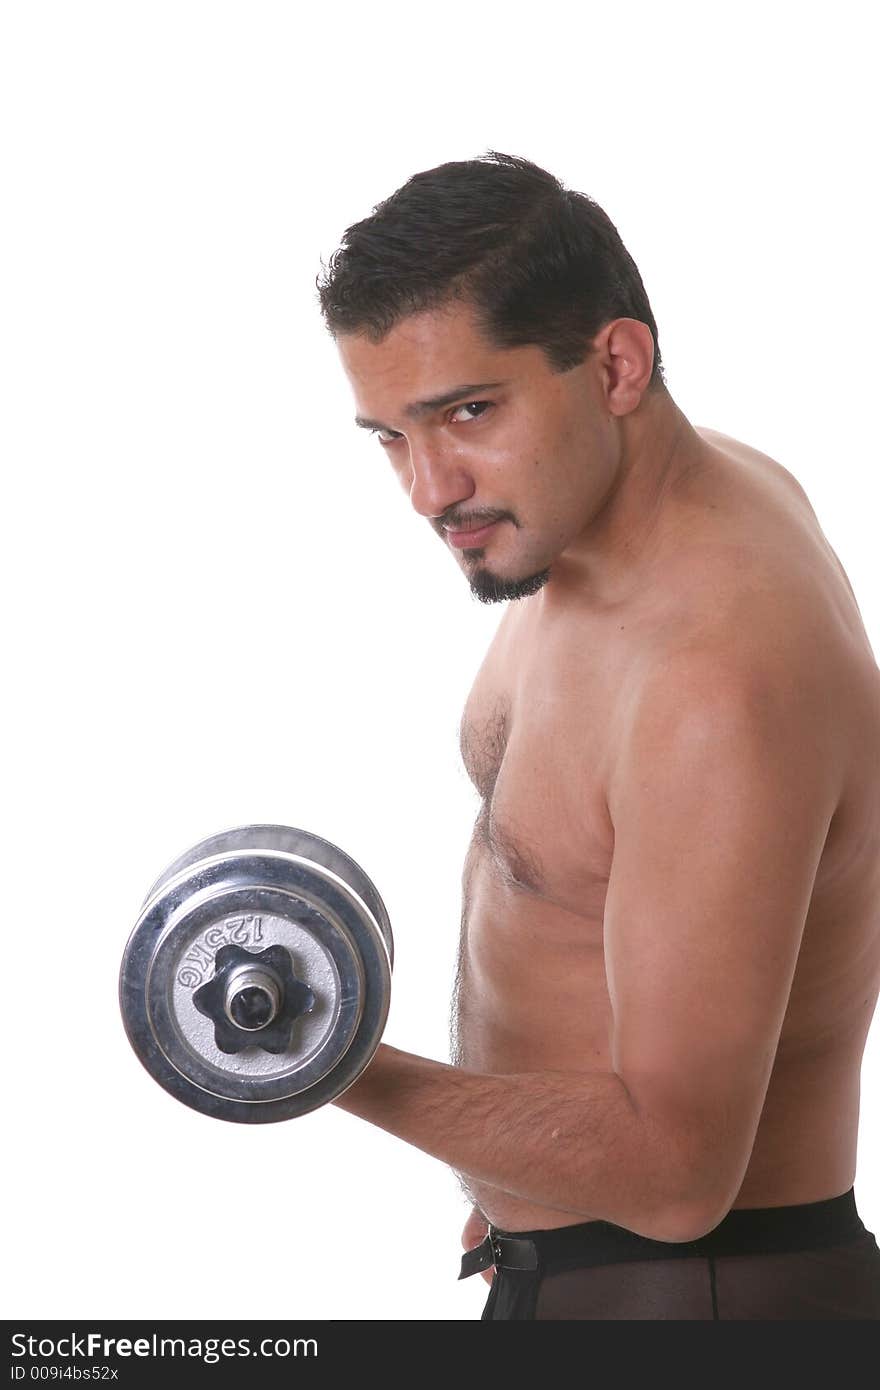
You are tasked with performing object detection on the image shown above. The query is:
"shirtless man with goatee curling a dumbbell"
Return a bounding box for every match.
[315,154,880,1319]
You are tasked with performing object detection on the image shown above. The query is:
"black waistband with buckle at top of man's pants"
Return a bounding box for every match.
[459,1187,866,1279]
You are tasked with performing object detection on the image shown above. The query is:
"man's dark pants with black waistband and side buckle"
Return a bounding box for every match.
[459,1187,880,1321]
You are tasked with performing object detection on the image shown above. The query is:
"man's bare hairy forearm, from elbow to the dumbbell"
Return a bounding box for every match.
[329,1044,700,1240]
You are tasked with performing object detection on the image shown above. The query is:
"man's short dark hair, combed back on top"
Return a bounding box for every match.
[316,150,666,391]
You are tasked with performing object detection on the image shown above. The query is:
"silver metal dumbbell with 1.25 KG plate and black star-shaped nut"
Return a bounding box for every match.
[120,826,393,1125]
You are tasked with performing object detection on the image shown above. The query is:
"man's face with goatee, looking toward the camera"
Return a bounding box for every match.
[338,303,610,603]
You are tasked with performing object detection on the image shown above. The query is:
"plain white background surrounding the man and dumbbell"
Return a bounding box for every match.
[0,0,880,1319]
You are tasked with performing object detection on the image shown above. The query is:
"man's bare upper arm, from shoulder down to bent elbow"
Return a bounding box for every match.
[605,653,840,1229]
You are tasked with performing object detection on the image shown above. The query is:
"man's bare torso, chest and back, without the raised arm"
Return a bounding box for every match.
[455,430,880,1229]
